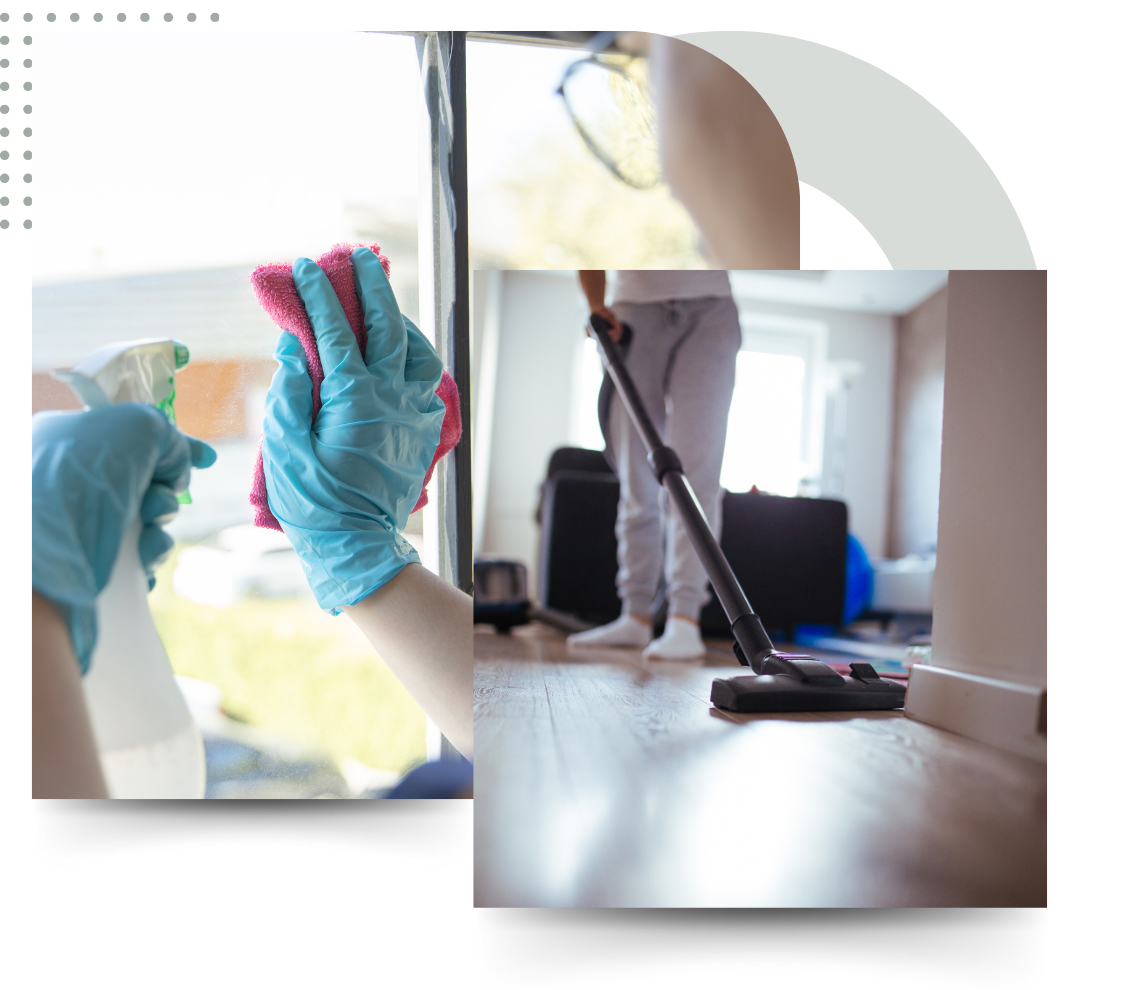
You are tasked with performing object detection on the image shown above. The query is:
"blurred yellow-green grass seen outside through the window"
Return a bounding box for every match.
[149,547,425,771]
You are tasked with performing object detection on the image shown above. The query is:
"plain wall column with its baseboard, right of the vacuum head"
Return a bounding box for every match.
[906,271,1047,762]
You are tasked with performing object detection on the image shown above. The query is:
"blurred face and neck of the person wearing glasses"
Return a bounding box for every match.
[650,35,801,269]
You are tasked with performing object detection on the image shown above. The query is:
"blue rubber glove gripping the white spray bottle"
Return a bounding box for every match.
[32,403,215,674]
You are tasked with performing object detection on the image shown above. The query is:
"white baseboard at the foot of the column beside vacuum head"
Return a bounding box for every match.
[906,664,1047,763]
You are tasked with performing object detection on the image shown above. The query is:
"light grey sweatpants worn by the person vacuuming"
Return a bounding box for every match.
[606,298,743,619]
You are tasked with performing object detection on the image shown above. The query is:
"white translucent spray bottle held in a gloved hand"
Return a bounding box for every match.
[54,338,207,798]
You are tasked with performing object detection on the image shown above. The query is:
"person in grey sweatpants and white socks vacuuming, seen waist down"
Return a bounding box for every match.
[567,271,743,660]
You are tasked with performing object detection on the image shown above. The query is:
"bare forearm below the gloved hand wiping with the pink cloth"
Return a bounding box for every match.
[343,564,473,759]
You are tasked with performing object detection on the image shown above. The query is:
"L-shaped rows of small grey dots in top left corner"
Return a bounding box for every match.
[0,10,221,231]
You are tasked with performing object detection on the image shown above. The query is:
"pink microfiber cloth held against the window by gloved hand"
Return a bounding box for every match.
[250,244,461,532]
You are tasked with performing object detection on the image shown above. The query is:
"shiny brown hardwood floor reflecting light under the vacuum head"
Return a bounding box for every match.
[474,624,1047,907]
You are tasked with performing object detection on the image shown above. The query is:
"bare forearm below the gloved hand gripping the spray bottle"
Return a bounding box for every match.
[32,592,109,800]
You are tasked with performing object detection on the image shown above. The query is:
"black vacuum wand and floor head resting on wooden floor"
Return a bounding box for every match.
[587,314,907,712]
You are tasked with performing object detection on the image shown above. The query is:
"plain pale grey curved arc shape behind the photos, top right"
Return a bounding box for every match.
[676,32,1035,269]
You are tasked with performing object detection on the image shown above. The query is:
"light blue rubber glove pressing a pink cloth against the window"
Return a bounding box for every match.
[262,248,446,614]
